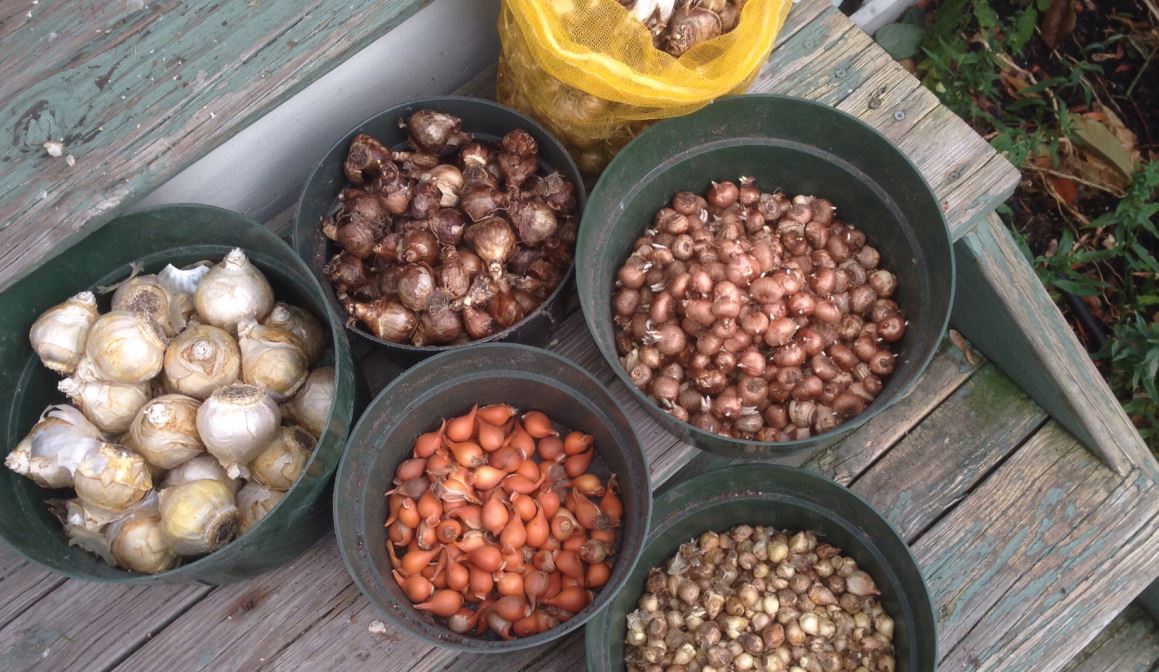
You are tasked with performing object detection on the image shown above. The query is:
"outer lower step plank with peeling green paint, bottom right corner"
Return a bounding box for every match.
[914,422,1159,670]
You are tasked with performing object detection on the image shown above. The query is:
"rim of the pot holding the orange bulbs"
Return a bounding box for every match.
[334,343,655,655]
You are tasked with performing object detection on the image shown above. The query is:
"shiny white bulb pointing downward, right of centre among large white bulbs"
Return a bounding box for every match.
[197,384,282,479]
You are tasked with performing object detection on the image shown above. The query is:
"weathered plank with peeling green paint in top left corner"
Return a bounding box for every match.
[0,0,433,287]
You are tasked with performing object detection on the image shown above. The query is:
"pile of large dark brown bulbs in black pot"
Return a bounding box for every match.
[322,110,577,346]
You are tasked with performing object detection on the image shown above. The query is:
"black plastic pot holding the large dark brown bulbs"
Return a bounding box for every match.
[293,96,586,363]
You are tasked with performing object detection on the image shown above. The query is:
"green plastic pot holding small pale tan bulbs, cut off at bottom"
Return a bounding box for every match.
[584,465,938,672]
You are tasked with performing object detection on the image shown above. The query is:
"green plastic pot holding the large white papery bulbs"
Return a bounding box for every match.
[0,205,356,584]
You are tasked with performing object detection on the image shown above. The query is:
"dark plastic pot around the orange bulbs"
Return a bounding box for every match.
[334,344,651,653]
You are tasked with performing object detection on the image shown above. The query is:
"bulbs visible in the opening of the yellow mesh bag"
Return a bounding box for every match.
[620,0,744,58]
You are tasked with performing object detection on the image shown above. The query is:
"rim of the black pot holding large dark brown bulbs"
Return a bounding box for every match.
[292,96,588,356]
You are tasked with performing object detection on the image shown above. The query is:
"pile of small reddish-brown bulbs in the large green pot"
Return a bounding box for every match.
[612,178,907,441]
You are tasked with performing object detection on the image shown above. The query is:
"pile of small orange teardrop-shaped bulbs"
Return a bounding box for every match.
[386,403,624,640]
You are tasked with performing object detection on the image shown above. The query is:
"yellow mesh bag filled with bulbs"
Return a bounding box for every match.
[496,0,792,175]
